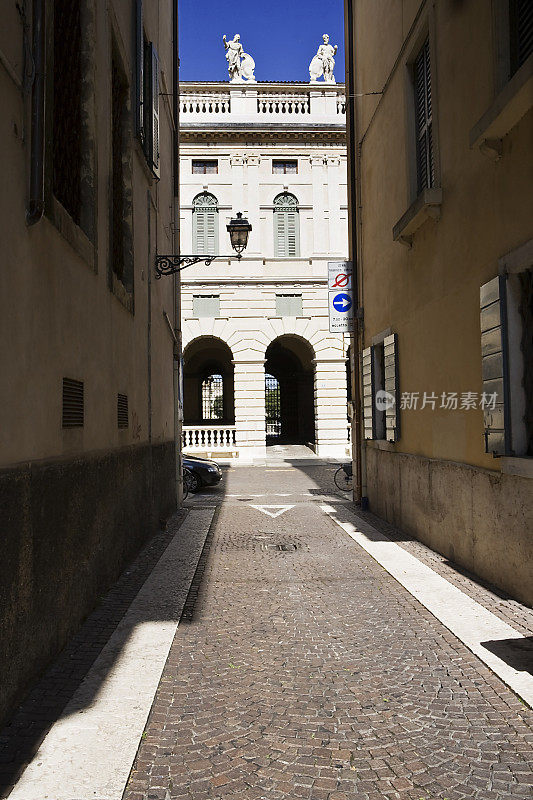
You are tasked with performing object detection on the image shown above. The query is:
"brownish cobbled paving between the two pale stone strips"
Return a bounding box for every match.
[124,465,533,800]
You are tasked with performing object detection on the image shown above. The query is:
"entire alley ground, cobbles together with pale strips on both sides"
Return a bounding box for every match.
[2,454,533,800]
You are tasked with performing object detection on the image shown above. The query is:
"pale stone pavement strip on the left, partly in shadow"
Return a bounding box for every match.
[9,509,214,800]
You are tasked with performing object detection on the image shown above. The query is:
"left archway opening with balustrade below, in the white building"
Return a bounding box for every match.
[183,336,235,425]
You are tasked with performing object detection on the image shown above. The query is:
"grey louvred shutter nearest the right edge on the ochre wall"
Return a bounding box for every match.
[479,275,511,455]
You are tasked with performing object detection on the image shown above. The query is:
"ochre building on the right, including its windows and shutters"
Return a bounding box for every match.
[345,0,533,603]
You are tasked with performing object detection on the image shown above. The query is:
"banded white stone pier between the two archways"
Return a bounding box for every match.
[232,359,266,461]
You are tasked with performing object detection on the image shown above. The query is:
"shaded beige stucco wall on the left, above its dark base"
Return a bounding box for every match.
[0,0,178,466]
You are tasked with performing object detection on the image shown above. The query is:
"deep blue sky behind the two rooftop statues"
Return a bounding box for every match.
[179,0,344,83]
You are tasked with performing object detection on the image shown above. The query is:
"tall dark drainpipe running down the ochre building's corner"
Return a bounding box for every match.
[344,0,363,503]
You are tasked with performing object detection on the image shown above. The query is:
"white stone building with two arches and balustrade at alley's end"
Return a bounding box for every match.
[180,82,349,461]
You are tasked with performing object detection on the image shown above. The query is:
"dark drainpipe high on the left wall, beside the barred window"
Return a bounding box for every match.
[26,0,46,225]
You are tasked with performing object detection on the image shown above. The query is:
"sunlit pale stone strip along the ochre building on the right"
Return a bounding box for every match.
[321,504,533,706]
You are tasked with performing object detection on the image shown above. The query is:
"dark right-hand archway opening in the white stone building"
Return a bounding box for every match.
[265,335,315,446]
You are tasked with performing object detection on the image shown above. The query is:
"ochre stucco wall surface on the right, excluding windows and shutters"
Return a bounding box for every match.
[346,0,533,603]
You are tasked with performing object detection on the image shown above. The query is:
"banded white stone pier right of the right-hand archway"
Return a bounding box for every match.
[313,358,349,458]
